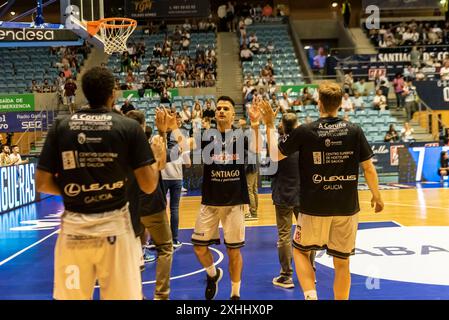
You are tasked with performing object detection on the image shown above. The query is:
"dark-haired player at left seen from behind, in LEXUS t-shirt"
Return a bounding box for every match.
[36,67,165,300]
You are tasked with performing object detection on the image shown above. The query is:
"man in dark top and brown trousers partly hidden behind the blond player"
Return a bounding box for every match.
[271,112,315,289]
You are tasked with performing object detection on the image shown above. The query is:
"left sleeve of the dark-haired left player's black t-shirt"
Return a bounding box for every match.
[37,120,61,174]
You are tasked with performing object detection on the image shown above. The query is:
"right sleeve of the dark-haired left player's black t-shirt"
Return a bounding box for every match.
[128,121,156,170]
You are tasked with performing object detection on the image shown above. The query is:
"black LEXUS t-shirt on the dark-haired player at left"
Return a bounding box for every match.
[38,109,154,214]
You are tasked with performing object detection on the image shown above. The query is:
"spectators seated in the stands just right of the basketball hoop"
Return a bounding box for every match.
[114,20,217,93]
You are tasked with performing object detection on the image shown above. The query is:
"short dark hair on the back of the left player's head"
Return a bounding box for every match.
[81,67,115,109]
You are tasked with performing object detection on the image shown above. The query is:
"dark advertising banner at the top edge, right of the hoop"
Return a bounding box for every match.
[126,0,210,19]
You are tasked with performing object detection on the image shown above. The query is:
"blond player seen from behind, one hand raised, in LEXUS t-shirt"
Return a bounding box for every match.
[260,82,384,300]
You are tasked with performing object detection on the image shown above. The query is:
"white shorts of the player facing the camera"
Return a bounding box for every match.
[192,205,245,249]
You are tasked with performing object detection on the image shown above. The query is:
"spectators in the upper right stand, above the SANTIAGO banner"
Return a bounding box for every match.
[368,20,449,48]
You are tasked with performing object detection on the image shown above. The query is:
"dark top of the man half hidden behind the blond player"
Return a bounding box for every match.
[271,137,300,207]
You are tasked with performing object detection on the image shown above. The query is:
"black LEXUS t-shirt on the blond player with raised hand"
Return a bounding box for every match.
[279,118,373,216]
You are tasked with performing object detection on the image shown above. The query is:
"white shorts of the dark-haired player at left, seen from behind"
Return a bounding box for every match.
[53,206,143,300]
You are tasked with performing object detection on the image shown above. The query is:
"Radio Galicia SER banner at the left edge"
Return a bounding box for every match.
[0,112,53,133]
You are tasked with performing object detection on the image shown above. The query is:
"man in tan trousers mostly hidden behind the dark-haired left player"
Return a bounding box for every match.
[126,110,173,300]
